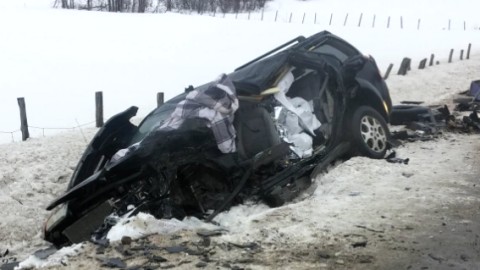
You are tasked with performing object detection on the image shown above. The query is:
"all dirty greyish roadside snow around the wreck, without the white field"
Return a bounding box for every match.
[0,55,480,269]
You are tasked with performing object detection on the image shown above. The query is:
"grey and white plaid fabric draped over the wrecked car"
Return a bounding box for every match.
[159,74,238,153]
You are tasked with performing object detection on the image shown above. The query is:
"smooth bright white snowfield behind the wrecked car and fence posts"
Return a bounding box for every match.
[0,0,480,143]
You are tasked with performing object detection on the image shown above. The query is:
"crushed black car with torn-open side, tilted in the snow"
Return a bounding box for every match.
[44,31,392,246]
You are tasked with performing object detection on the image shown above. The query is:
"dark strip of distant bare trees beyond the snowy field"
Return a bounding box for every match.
[55,0,268,14]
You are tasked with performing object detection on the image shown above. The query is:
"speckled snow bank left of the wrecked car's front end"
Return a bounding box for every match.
[0,129,96,257]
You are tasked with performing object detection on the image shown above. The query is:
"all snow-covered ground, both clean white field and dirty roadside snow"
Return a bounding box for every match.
[0,0,480,269]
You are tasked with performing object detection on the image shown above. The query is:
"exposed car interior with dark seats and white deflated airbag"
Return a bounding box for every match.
[235,66,336,159]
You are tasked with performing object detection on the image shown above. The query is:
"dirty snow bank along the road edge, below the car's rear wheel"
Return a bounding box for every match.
[210,134,480,247]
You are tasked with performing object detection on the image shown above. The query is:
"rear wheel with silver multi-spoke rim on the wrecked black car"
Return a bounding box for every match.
[350,106,389,159]
